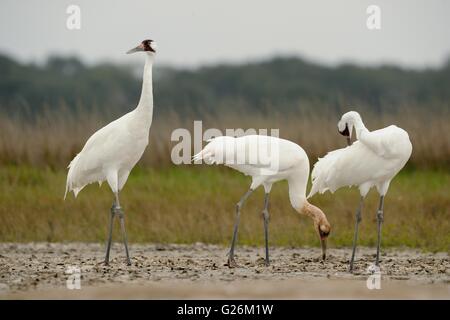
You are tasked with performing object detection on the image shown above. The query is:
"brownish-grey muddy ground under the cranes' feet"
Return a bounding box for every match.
[0,243,450,299]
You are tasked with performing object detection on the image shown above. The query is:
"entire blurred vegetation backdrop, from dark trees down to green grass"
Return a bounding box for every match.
[0,55,450,251]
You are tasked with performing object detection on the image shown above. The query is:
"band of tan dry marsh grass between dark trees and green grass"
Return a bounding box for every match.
[0,108,450,168]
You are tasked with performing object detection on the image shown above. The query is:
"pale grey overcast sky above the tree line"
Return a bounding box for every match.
[0,0,450,68]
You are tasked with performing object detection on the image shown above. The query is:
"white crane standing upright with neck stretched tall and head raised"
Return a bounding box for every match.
[64,40,156,265]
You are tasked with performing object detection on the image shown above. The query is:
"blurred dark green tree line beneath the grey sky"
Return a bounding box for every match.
[0,55,450,115]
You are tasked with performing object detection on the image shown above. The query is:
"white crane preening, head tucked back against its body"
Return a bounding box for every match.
[308,111,412,271]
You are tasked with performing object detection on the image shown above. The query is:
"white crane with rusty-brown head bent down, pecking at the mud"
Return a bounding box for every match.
[194,135,331,267]
